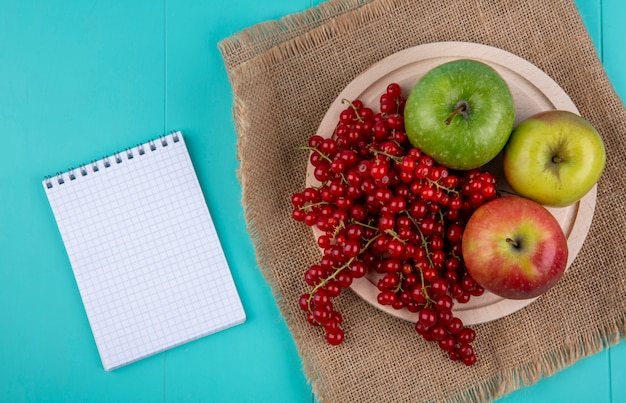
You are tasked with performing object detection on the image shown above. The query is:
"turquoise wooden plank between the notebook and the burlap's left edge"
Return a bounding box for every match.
[165,0,312,402]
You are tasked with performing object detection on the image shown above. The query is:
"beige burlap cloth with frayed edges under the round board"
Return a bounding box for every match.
[219,0,626,402]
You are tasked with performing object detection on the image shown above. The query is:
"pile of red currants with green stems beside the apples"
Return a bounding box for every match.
[291,83,497,365]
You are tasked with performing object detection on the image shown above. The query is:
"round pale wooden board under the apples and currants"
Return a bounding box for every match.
[306,42,597,325]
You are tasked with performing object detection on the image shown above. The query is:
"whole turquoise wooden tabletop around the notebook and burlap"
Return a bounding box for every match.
[0,0,626,403]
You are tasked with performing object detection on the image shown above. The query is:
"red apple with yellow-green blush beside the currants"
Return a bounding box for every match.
[462,196,568,299]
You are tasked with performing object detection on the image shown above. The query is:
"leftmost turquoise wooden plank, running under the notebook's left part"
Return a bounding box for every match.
[0,0,164,402]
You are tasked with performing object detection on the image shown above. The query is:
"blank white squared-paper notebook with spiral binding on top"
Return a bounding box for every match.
[43,132,246,371]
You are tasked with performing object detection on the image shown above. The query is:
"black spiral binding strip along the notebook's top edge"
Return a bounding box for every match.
[44,131,182,189]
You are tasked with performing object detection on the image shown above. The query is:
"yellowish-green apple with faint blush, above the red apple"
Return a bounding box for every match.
[503,110,606,207]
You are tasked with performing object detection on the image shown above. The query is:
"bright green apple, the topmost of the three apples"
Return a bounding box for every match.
[404,59,515,170]
